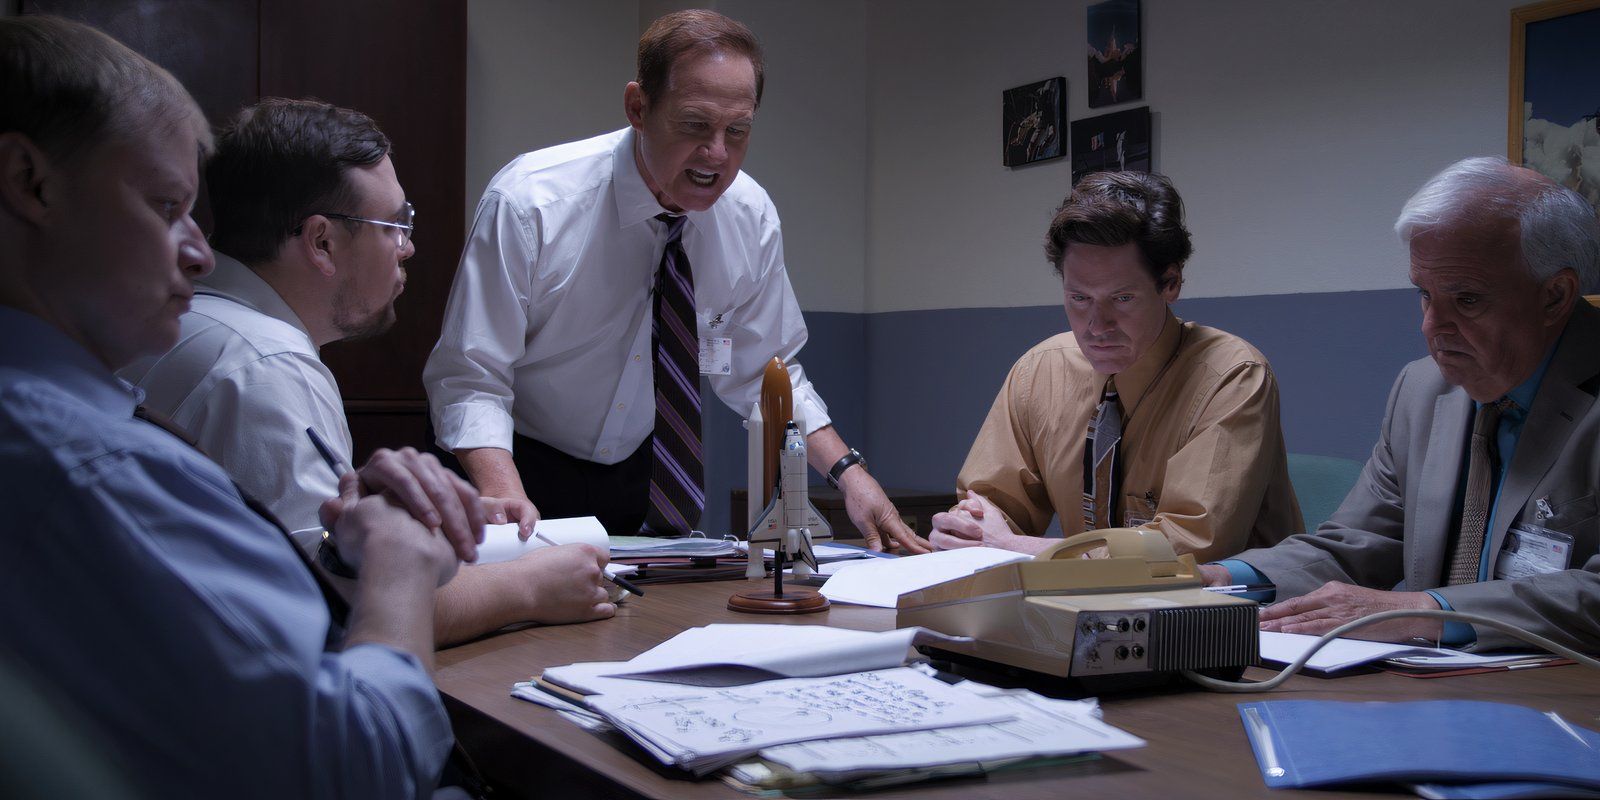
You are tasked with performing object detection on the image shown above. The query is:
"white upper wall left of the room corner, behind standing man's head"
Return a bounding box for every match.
[464,0,867,312]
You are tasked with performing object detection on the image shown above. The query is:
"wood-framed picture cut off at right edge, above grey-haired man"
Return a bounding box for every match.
[1506,0,1600,208]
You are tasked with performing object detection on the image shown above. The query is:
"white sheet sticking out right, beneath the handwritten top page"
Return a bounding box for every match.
[762,691,1144,776]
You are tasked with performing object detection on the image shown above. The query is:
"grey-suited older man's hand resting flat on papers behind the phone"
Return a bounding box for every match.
[1260,579,1443,642]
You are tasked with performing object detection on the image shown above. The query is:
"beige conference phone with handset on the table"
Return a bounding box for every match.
[894,528,1259,688]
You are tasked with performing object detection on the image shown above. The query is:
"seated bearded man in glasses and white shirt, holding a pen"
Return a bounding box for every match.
[120,98,616,645]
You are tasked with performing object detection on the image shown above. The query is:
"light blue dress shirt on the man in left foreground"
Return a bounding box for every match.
[0,307,451,798]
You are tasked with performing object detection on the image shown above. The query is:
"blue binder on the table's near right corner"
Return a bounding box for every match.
[1238,701,1600,790]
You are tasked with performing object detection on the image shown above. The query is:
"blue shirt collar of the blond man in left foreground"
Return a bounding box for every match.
[0,306,144,418]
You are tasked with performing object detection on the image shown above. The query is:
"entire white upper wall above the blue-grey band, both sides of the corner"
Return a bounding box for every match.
[466,0,1522,312]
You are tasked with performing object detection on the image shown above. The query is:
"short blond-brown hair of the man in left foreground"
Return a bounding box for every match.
[0,16,211,162]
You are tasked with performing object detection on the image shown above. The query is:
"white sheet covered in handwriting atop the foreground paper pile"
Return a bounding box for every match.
[587,667,1016,774]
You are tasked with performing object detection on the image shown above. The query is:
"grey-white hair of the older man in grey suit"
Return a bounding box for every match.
[1395,155,1600,294]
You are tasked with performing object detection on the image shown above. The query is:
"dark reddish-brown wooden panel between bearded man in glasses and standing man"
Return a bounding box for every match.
[261,0,467,403]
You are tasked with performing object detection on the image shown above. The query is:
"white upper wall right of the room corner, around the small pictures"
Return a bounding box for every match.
[866,0,1522,312]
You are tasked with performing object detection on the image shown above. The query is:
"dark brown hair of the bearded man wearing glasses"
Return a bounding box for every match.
[206,98,389,266]
